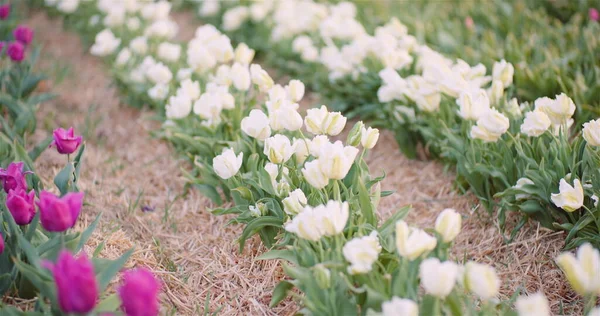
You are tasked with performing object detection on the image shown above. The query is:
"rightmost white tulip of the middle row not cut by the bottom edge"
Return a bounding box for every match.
[464,261,500,300]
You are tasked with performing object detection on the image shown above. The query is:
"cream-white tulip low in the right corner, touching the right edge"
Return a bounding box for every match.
[556,243,600,296]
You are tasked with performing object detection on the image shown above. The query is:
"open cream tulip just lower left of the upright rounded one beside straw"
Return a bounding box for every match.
[396,220,437,261]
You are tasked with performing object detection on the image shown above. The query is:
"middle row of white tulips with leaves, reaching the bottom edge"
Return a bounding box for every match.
[37,0,600,316]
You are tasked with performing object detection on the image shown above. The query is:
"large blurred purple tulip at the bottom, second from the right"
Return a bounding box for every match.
[43,250,98,314]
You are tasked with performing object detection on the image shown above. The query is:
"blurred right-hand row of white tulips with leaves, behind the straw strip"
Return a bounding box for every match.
[190,1,600,248]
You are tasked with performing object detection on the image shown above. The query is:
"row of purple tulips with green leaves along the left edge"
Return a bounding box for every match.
[0,3,160,315]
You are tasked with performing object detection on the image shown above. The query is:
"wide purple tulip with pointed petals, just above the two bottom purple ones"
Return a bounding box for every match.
[37,191,83,232]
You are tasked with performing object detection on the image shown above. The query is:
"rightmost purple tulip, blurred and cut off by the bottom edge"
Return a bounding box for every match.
[117,268,160,316]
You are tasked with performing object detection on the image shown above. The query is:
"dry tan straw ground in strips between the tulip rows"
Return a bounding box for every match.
[17,9,577,315]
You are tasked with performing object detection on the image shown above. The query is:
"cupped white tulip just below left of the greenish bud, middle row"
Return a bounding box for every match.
[319,140,358,180]
